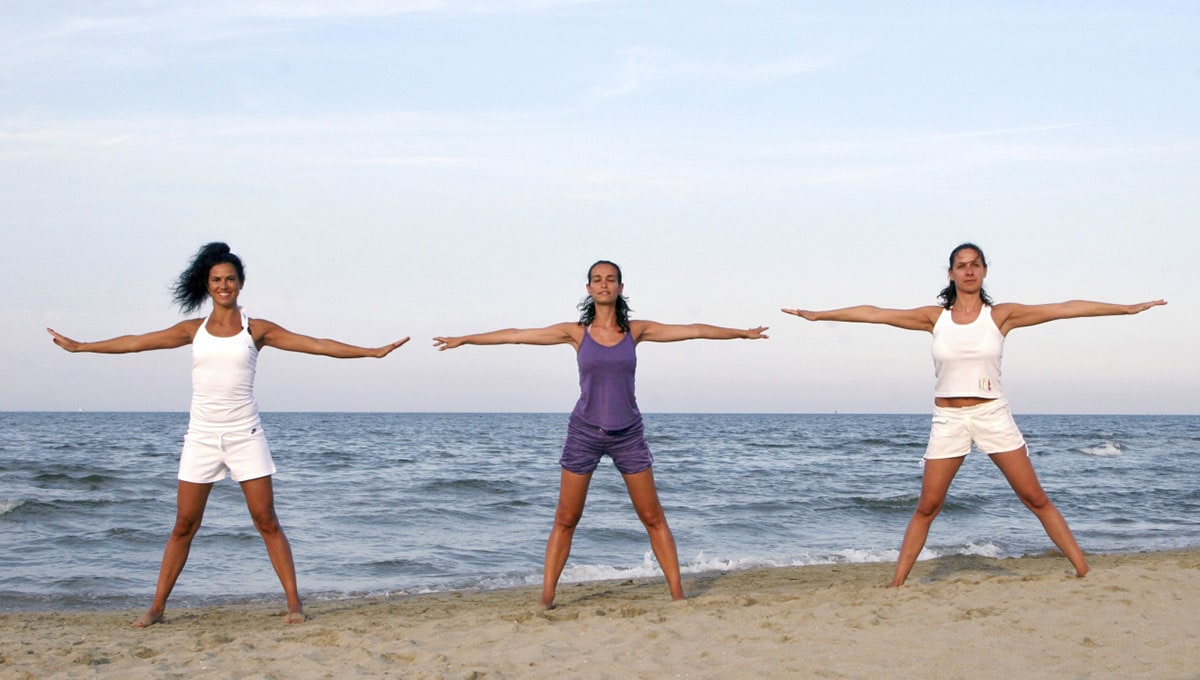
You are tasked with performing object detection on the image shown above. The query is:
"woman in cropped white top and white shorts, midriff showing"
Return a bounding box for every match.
[784,243,1166,586]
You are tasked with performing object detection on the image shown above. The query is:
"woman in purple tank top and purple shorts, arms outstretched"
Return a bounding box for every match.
[433,260,767,608]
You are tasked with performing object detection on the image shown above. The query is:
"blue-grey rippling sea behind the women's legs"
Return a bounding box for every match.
[0,413,1200,612]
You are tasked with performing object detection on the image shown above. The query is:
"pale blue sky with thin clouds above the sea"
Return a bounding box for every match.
[0,0,1200,414]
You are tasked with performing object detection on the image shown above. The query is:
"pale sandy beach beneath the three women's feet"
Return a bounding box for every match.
[0,550,1200,680]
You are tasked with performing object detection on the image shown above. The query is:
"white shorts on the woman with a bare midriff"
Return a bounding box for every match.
[923,399,1025,461]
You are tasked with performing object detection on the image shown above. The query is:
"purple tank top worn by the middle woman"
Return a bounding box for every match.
[571,329,642,431]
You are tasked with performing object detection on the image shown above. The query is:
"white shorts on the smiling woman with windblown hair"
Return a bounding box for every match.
[179,426,275,485]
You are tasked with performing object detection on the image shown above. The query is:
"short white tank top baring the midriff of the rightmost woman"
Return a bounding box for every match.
[932,305,1004,399]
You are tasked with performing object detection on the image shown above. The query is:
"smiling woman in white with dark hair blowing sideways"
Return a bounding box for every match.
[47,242,408,627]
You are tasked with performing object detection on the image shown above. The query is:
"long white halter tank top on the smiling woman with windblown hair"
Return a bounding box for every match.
[188,313,260,432]
